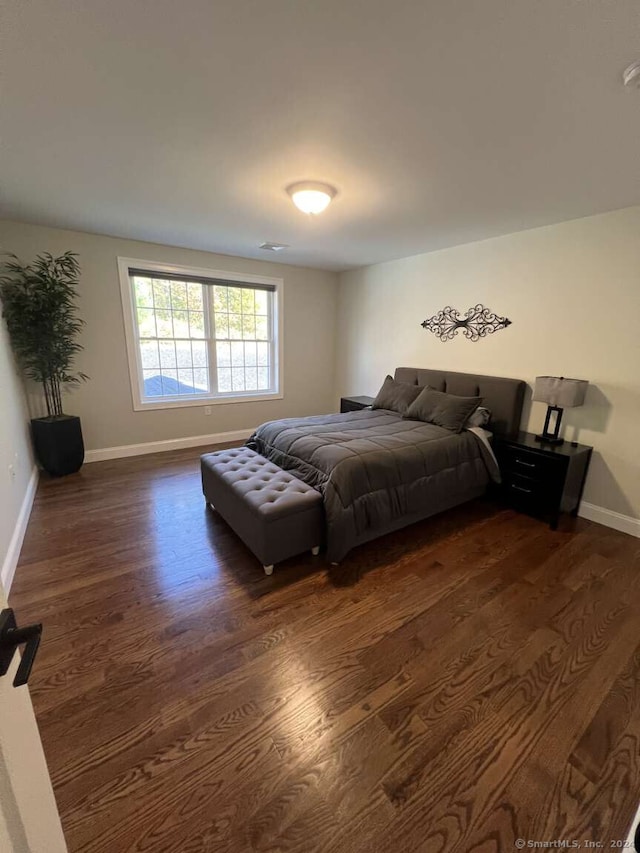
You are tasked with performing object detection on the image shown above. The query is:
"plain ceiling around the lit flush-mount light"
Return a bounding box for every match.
[0,0,640,270]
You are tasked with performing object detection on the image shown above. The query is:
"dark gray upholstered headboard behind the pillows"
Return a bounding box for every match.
[395,367,527,435]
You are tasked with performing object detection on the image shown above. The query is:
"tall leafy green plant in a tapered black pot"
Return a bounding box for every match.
[0,252,87,477]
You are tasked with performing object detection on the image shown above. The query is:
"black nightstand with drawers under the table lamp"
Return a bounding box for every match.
[493,432,593,530]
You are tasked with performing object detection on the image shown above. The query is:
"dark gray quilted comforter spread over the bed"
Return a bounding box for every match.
[247,409,496,562]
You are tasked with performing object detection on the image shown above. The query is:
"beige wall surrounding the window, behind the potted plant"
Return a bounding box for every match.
[0,221,338,449]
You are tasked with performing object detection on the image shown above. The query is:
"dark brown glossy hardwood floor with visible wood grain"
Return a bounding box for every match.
[11,450,640,853]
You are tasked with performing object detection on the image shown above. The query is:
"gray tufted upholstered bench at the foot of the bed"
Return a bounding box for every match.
[200,447,324,575]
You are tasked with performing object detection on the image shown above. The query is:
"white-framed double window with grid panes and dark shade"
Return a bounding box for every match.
[118,258,282,409]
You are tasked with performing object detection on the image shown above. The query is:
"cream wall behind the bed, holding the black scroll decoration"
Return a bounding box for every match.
[337,207,640,518]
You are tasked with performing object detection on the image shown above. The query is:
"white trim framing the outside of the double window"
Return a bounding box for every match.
[118,257,284,412]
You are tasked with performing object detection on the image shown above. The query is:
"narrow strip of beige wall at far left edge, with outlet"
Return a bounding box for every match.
[0,312,33,583]
